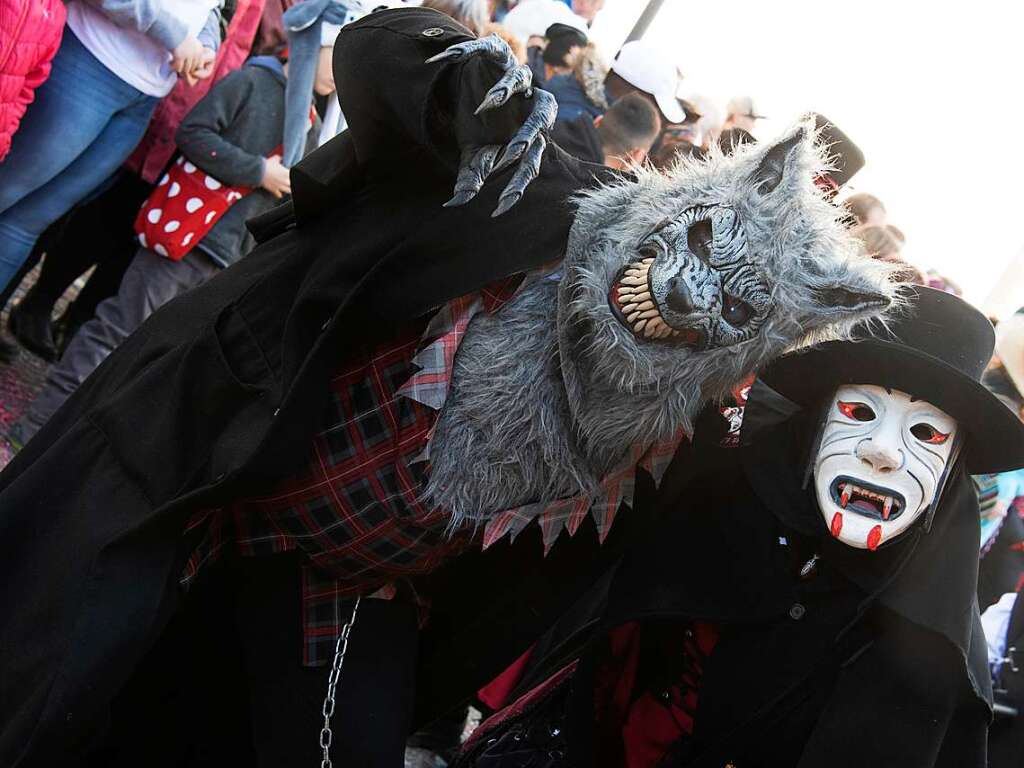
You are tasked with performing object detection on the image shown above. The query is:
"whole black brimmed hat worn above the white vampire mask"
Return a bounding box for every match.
[760,286,1024,474]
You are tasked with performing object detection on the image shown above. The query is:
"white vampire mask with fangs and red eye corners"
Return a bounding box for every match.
[814,384,956,550]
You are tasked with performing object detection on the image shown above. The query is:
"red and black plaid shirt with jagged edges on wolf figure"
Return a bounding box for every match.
[180,279,683,666]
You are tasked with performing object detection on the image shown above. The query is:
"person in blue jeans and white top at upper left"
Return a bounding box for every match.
[0,0,220,290]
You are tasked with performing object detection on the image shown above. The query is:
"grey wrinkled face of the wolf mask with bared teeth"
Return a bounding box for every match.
[608,206,769,350]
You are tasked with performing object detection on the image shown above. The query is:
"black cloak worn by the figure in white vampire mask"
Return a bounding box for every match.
[468,415,991,768]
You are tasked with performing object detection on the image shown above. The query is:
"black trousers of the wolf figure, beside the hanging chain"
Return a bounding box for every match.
[86,555,417,768]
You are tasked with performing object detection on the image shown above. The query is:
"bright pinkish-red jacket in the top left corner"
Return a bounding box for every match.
[0,0,67,161]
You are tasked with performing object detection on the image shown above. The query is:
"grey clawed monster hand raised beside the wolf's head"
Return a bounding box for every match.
[427,35,558,216]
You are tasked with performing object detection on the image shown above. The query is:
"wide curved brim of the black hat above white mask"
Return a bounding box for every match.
[759,338,1024,474]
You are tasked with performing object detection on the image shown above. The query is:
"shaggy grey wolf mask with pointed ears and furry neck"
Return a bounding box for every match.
[427,124,894,524]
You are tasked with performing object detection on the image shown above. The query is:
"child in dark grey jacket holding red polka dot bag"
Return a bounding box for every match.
[0,37,337,456]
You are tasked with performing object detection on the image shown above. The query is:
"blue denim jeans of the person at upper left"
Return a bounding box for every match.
[0,29,159,290]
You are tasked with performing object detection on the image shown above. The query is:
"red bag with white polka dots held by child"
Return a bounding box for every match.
[135,151,270,261]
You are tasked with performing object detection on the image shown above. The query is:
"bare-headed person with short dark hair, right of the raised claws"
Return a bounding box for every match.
[552,93,660,169]
